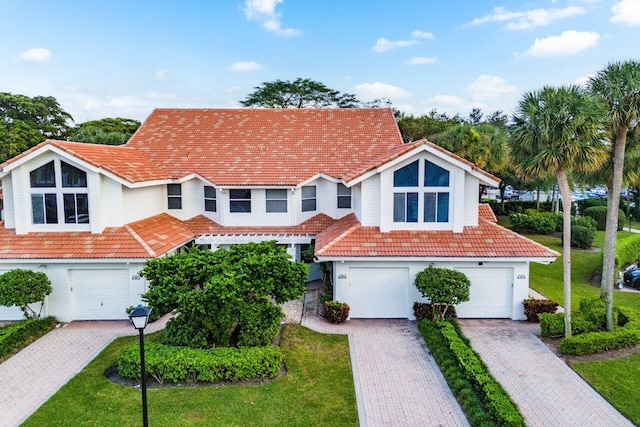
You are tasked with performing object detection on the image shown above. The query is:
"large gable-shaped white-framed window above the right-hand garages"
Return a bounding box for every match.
[393,159,450,223]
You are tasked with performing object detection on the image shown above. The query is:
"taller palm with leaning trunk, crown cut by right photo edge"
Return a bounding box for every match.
[589,61,640,331]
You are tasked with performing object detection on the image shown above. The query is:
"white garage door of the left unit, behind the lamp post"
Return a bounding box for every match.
[69,269,131,320]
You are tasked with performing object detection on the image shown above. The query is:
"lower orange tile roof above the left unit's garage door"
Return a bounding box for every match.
[0,214,194,259]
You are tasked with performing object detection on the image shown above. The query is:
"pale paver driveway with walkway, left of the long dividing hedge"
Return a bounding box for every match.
[302,291,469,427]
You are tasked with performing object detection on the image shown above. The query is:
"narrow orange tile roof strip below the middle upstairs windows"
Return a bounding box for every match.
[185,214,337,235]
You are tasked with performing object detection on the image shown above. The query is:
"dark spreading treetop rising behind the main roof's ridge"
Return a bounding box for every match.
[240,77,361,108]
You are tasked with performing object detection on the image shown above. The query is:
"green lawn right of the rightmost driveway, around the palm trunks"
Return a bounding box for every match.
[529,231,640,425]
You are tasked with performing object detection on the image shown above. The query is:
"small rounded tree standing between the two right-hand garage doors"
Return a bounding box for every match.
[413,266,471,320]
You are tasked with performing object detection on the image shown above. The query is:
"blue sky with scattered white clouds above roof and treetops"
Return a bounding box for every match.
[0,0,640,123]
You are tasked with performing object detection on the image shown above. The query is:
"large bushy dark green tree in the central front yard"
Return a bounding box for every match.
[141,241,307,348]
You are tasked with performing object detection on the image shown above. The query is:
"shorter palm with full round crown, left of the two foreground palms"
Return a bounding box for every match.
[510,86,605,337]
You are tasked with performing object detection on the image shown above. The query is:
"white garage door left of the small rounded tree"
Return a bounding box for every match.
[349,267,409,319]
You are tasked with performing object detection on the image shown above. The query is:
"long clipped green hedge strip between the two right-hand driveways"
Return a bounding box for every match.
[418,320,524,426]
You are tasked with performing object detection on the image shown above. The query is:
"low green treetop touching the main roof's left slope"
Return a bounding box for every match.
[67,117,140,145]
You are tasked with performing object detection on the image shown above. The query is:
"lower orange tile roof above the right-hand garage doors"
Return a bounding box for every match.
[315,211,560,259]
